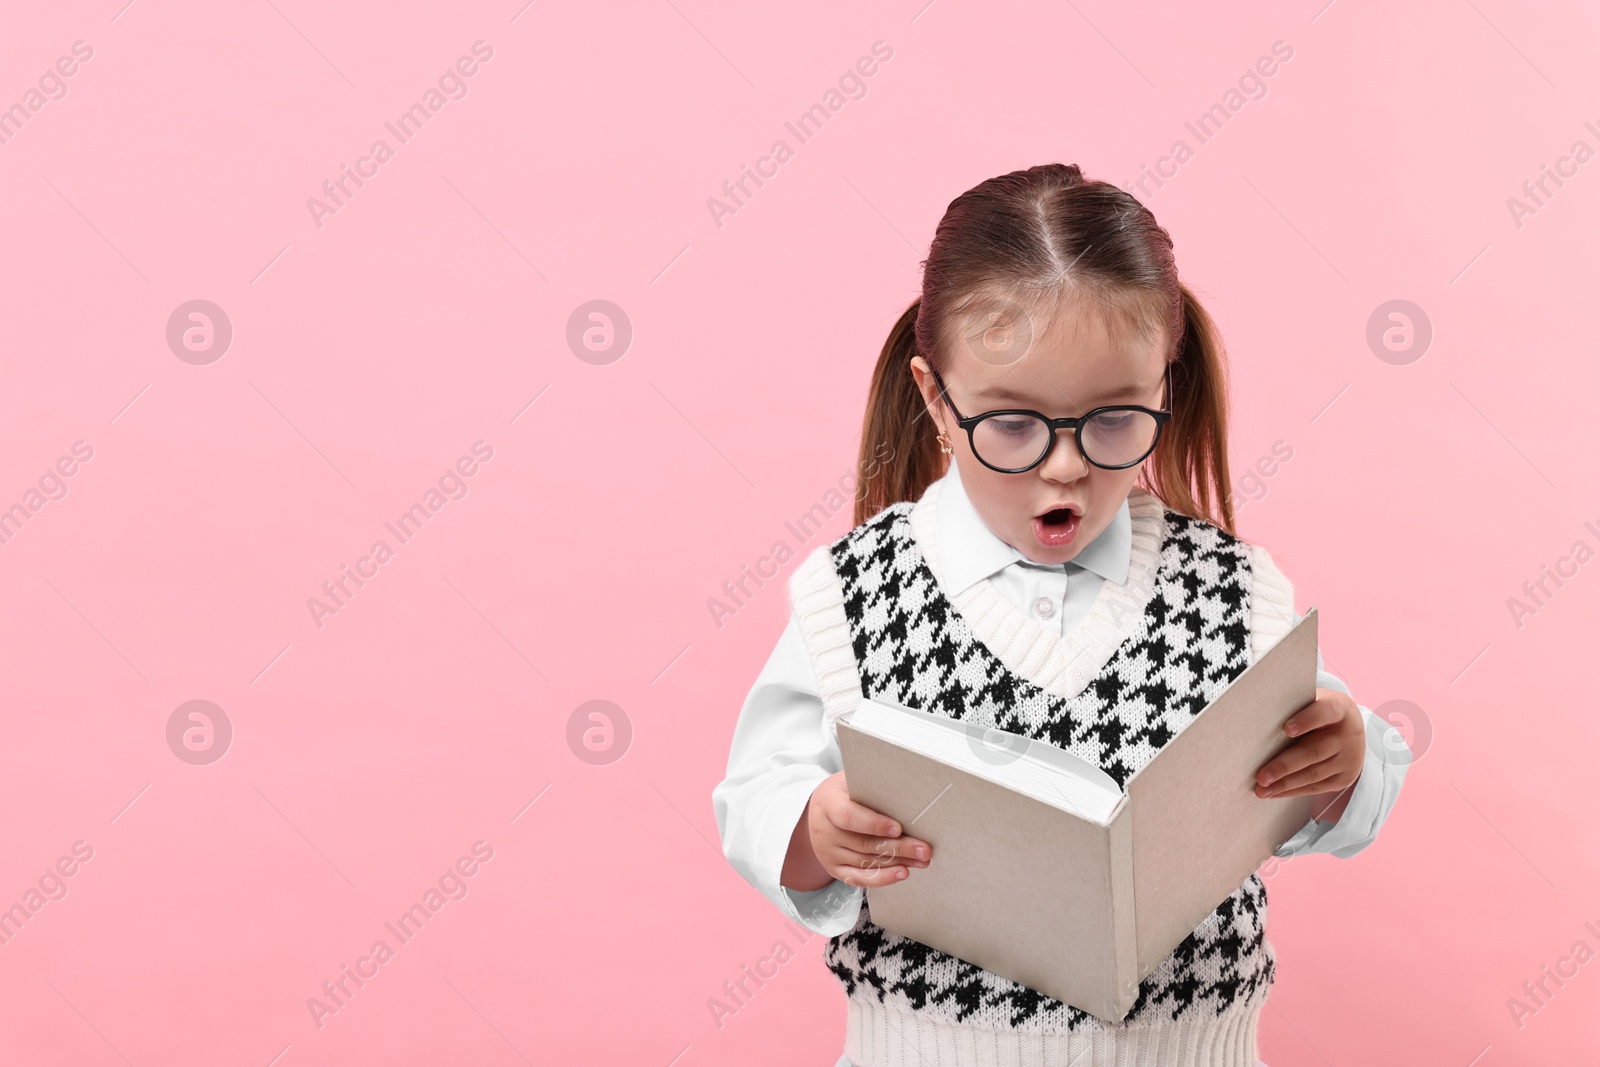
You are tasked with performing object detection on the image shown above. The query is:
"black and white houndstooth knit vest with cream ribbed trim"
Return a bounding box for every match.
[792,483,1283,1067]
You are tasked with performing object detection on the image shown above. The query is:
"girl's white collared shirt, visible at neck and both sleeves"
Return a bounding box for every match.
[712,464,1406,936]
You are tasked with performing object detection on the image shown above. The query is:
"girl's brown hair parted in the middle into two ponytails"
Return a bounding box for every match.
[854,163,1234,534]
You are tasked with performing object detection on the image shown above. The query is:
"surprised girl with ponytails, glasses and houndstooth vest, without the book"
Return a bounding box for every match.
[712,163,1410,1067]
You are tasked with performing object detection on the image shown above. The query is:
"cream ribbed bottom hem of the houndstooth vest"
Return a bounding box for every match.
[845,987,1270,1067]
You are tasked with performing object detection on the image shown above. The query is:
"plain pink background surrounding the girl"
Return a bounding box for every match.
[0,0,1600,1067]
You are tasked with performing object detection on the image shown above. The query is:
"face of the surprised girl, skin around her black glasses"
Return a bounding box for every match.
[910,295,1168,563]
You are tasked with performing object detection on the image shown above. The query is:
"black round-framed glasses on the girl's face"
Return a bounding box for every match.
[933,363,1173,474]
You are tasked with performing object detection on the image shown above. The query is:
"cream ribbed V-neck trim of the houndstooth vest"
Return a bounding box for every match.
[909,482,1168,699]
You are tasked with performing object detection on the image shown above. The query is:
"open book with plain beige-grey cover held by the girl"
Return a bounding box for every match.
[838,608,1317,1022]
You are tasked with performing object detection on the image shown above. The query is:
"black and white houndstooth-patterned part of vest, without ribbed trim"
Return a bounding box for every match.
[824,502,1275,1032]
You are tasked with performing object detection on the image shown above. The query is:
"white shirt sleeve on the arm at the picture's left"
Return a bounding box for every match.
[710,613,866,937]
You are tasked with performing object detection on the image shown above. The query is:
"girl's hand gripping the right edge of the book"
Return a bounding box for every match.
[1256,688,1366,822]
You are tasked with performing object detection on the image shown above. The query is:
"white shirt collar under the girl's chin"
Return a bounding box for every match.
[934,462,1133,597]
